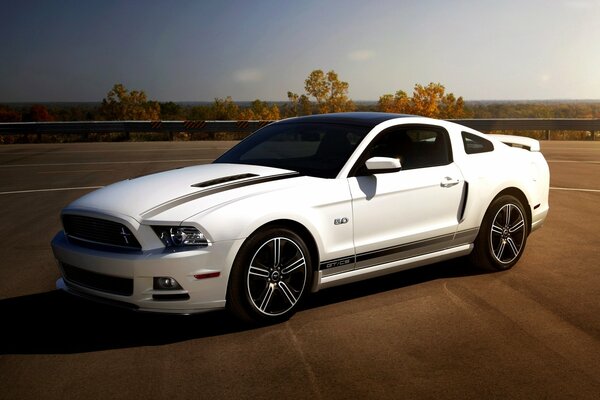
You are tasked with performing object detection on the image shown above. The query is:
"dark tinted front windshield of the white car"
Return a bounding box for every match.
[215,122,369,178]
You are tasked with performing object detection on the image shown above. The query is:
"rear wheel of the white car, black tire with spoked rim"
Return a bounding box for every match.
[470,195,529,271]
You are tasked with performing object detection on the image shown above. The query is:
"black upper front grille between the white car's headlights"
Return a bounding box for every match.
[63,214,142,250]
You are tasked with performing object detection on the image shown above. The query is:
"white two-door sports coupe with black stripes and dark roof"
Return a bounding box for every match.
[52,113,549,323]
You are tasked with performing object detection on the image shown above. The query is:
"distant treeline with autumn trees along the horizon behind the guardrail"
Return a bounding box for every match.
[0,69,600,143]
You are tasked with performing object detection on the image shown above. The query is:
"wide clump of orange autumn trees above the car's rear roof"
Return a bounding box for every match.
[377,82,465,119]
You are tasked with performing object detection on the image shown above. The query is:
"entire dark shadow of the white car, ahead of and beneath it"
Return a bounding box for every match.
[0,259,481,354]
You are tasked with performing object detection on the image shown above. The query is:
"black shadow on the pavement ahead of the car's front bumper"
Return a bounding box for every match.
[0,290,246,354]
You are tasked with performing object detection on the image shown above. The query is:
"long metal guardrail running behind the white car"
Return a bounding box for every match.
[0,118,600,140]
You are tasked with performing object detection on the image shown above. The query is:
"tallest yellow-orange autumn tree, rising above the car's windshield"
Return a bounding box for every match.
[304,69,355,114]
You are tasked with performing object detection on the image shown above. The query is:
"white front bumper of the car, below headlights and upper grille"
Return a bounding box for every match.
[52,232,243,314]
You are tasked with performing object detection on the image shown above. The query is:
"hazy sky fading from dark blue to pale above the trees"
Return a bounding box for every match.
[0,0,600,102]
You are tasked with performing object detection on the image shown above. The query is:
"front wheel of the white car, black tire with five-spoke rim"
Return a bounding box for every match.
[227,228,312,324]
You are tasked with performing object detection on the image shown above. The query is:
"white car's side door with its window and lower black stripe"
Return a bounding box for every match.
[348,125,465,268]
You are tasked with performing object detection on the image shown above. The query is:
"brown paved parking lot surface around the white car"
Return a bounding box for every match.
[0,142,600,400]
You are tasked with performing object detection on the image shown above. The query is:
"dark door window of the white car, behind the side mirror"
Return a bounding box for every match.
[355,126,452,175]
